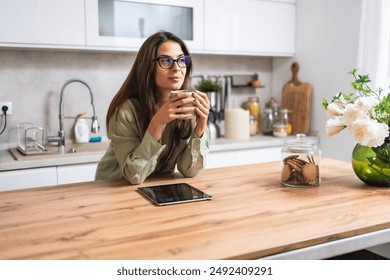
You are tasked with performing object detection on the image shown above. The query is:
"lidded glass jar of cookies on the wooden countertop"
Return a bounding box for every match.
[281,134,321,187]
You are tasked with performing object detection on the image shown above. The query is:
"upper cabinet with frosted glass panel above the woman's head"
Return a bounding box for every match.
[85,0,204,50]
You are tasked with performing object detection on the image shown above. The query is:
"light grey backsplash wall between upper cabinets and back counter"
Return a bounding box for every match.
[0,50,277,149]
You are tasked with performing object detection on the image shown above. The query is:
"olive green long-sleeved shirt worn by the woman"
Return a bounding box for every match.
[95,100,209,184]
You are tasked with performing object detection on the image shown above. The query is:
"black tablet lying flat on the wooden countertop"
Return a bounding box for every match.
[138,183,212,205]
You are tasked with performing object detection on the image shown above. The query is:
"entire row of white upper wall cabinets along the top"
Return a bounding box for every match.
[0,0,296,56]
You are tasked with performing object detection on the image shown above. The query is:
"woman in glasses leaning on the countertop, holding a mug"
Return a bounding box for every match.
[95,31,210,184]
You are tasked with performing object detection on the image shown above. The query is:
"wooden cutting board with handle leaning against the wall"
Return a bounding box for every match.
[282,62,312,135]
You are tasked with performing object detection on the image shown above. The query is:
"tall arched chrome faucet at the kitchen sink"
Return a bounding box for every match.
[47,79,99,148]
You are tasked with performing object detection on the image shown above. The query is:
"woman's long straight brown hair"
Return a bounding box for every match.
[106,31,192,141]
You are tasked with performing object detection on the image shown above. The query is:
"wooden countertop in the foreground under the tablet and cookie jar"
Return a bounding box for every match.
[0,159,390,259]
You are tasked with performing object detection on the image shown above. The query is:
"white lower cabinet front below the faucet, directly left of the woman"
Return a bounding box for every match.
[57,163,98,184]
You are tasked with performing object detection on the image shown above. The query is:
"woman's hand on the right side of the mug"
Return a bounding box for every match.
[193,90,210,137]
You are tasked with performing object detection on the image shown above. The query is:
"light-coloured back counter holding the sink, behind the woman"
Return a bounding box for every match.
[0,135,288,171]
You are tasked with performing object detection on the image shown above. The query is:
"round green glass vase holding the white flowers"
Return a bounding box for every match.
[352,137,390,187]
